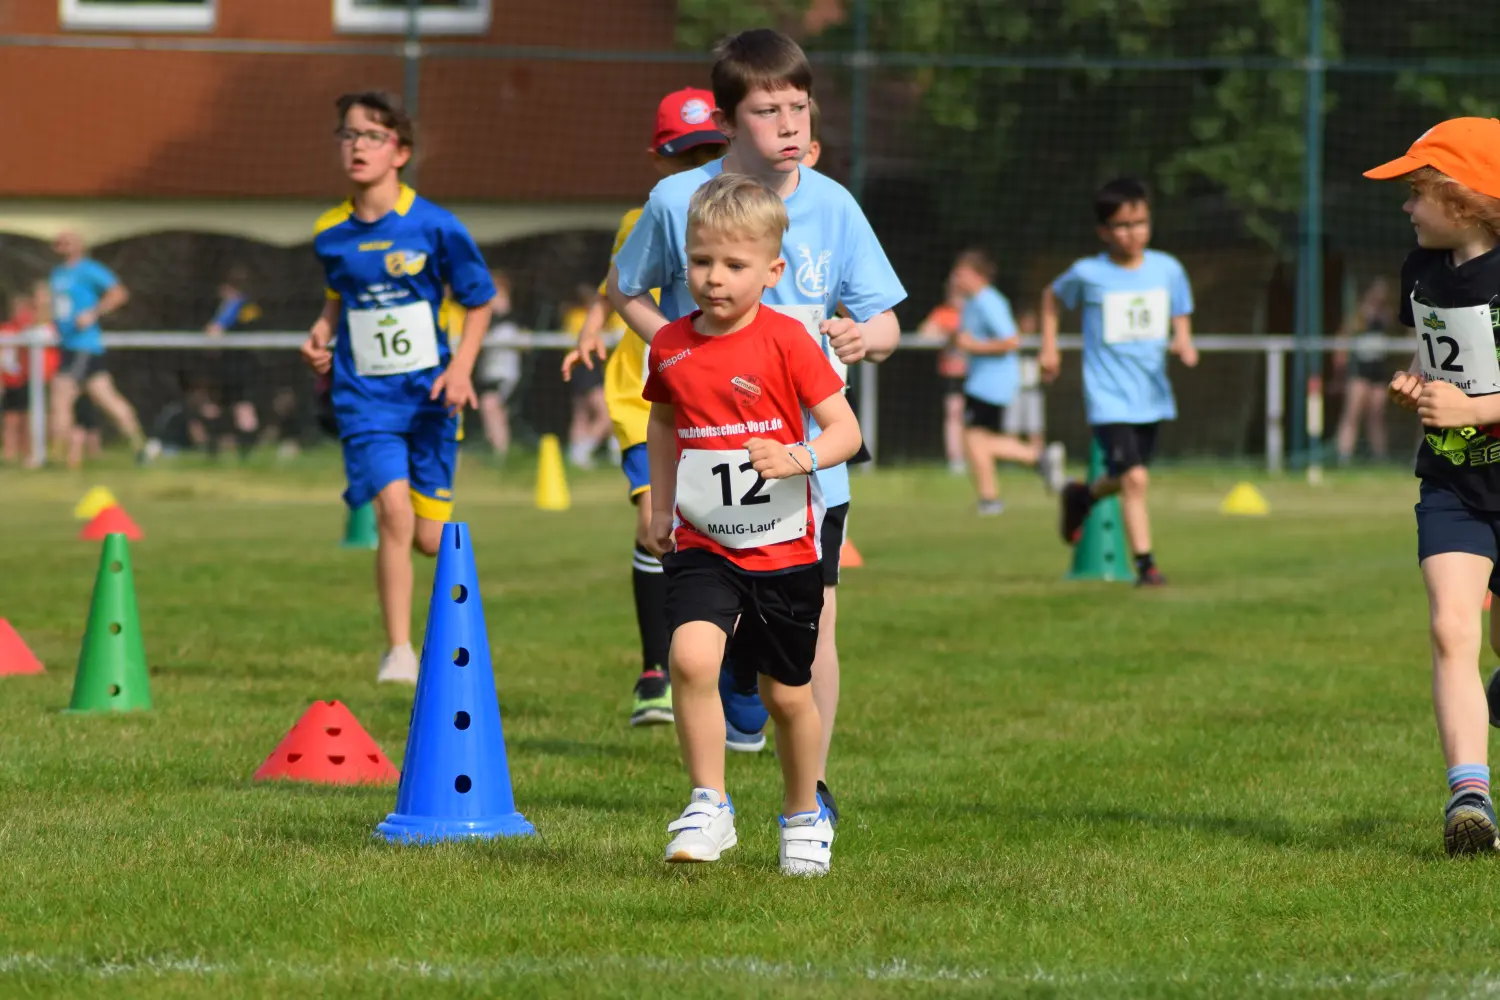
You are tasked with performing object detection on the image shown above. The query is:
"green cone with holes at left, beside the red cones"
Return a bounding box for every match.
[68,534,152,712]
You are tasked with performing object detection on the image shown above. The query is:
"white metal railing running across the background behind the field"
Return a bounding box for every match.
[11,330,1416,472]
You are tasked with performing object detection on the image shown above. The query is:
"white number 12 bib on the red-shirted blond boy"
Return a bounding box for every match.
[677,448,809,549]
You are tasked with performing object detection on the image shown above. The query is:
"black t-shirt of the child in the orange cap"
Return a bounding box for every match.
[1401,247,1500,511]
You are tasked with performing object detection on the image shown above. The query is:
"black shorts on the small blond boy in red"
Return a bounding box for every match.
[662,549,824,690]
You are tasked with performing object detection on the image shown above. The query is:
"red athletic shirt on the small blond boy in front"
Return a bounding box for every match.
[642,306,843,573]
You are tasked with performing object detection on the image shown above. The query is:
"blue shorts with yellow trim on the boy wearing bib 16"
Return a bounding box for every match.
[344,415,459,522]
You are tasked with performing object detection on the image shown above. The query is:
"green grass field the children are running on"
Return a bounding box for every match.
[0,459,1500,999]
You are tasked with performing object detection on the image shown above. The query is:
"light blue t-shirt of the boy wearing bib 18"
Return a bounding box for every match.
[1052,250,1193,424]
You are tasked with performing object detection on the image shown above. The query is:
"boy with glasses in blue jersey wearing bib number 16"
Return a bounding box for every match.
[302,93,495,684]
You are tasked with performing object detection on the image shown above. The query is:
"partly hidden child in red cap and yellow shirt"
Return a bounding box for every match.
[563,87,728,726]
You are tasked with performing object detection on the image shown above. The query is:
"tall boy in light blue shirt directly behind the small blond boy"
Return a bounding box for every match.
[608,28,906,827]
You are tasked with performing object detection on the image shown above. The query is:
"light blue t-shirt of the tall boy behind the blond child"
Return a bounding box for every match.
[615,160,906,507]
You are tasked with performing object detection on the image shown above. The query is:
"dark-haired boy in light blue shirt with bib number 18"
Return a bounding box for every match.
[1038,177,1199,586]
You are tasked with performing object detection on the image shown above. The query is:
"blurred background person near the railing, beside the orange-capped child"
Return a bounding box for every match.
[1334,277,1397,465]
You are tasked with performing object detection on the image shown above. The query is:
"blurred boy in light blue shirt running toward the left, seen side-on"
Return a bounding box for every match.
[948,250,1067,517]
